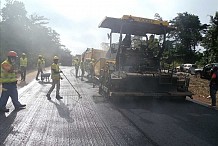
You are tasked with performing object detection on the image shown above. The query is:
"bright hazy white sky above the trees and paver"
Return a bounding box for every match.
[2,0,218,55]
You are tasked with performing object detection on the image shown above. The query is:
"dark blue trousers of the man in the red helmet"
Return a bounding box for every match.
[0,82,21,108]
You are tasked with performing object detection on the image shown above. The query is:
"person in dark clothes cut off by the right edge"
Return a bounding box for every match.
[210,66,218,107]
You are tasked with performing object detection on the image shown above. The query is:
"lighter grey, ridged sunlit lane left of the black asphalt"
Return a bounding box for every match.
[0,67,152,146]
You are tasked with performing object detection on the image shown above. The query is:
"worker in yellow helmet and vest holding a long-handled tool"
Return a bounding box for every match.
[46,56,63,100]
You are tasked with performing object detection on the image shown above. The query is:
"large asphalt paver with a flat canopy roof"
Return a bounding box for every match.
[98,15,192,99]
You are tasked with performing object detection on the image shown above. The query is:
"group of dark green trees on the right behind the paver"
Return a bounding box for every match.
[165,12,218,66]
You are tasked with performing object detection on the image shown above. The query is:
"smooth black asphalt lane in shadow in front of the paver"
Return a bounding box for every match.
[113,96,218,146]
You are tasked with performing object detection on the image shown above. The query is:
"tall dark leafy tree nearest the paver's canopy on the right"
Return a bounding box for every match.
[170,12,206,63]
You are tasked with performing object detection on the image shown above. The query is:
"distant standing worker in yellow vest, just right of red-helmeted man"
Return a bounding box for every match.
[20,53,27,81]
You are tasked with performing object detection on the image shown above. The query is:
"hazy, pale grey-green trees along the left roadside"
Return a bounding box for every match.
[0,0,72,69]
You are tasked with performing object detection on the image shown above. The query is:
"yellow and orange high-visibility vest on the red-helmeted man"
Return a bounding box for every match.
[1,60,17,83]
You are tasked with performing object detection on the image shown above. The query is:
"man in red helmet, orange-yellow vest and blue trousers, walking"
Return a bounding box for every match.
[0,51,26,112]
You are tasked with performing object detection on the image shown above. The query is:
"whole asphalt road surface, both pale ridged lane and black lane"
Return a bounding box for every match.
[0,67,218,146]
